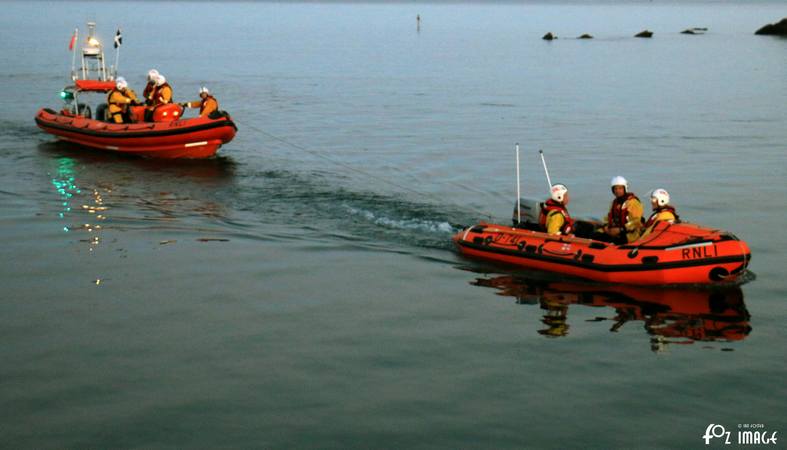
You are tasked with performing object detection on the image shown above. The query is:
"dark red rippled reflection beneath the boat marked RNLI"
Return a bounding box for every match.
[471,275,751,351]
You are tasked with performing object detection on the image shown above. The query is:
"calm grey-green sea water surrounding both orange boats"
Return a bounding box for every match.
[0,1,787,449]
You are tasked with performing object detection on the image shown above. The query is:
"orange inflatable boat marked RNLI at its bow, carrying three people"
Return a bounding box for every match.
[453,222,751,285]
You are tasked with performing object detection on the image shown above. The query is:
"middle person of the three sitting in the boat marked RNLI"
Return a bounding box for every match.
[600,176,643,244]
